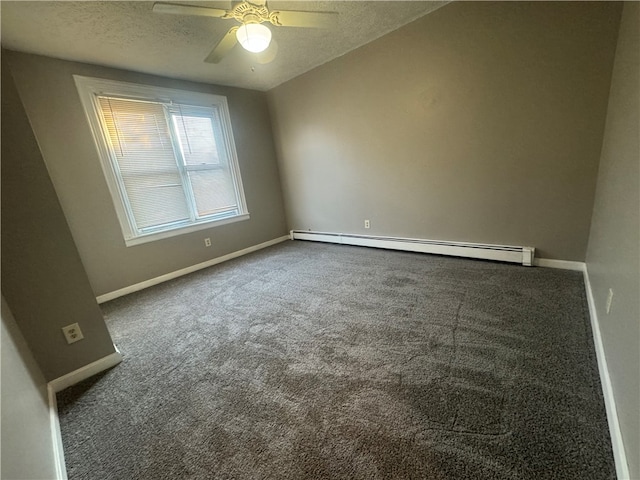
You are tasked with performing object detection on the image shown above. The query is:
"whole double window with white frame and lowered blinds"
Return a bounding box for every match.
[75,76,249,245]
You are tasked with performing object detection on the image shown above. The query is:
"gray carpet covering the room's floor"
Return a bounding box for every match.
[58,241,615,480]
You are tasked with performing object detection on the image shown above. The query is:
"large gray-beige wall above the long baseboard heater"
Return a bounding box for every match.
[269,2,621,261]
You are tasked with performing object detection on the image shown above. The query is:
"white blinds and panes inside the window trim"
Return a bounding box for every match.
[98,96,240,234]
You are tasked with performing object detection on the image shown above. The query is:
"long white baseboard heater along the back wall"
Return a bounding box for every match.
[290,230,536,266]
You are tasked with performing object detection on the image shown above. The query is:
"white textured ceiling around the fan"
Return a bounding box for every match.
[0,0,447,90]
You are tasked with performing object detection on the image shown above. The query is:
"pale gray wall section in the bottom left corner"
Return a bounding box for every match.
[0,297,56,480]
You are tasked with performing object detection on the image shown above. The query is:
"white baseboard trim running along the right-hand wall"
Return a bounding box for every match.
[583,265,631,480]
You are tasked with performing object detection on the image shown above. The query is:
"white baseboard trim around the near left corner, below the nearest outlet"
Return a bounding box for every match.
[47,345,122,480]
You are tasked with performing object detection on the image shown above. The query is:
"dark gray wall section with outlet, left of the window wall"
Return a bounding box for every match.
[2,55,114,380]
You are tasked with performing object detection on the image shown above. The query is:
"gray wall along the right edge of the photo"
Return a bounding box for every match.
[587,2,640,478]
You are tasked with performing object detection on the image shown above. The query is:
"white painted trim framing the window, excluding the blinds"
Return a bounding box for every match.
[73,75,250,247]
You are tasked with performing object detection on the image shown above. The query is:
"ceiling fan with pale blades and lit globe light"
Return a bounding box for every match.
[153,0,337,63]
